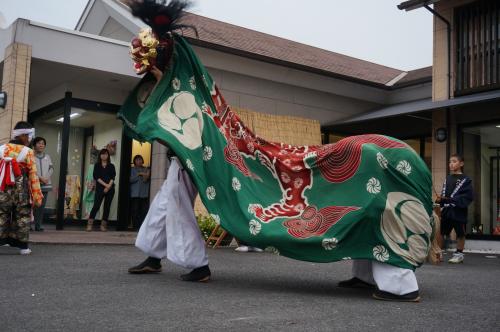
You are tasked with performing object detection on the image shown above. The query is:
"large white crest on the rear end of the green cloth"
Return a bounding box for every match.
[380,192,432,266]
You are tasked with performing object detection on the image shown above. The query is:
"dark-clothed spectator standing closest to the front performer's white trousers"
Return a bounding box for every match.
[130,155,151,230]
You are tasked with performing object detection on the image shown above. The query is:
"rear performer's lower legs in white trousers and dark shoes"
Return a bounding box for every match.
[339,259,420,302]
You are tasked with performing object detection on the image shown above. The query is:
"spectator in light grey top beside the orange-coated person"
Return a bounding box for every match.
[33,137,54,232]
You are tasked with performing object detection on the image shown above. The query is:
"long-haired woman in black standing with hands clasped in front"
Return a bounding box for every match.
[87,149,116,232]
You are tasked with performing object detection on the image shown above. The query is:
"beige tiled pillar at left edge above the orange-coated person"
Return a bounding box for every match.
[0,43,31,144]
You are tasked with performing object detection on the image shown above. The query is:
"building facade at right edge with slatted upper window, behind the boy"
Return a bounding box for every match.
[400,0,500,240]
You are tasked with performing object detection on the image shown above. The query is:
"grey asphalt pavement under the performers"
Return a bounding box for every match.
[0,244,500,332]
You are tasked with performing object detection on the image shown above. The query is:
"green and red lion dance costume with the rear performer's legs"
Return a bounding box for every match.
[120,0,433,301]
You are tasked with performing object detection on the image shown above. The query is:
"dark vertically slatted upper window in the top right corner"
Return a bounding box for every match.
[455,0,500,94]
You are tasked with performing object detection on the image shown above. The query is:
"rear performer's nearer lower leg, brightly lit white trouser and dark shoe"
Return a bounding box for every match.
[372,261,420,302]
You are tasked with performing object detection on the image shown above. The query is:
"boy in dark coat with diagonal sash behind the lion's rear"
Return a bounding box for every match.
[436,154,474,264]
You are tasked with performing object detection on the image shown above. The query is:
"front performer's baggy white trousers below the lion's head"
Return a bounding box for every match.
[135,158,208,269]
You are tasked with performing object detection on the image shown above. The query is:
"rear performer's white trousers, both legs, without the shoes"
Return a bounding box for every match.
[352,259,418,295]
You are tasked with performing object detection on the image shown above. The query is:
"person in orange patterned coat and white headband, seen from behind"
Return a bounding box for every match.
[0,121,43,255]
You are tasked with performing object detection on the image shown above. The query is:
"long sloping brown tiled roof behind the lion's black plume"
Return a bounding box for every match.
[183,13,403,85]
